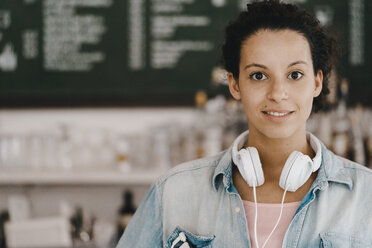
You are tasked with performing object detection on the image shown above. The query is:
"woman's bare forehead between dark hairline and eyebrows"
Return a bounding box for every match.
[240,29,312,64]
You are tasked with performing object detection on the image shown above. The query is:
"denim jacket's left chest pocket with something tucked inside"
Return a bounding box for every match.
[165,227,215,248]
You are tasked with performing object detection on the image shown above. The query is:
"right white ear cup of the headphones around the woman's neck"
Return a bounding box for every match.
[279,151,313,192]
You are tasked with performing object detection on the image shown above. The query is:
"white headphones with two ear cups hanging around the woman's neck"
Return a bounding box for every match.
[232,131,321,192]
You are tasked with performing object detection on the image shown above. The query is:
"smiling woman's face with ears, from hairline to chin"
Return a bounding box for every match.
[228,29,323,138]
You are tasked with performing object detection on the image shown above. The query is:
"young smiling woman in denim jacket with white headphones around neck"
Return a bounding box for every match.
[117,1,372,248]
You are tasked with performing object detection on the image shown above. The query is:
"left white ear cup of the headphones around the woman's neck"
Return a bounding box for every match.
[238,147,265,187]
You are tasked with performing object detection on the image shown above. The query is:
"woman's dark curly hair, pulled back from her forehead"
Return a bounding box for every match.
[221,0,337,112]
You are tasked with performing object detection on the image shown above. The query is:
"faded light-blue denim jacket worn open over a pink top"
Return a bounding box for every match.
[117,142,372,248]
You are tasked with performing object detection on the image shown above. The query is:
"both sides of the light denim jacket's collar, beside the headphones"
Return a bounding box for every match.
[212,142,353,192]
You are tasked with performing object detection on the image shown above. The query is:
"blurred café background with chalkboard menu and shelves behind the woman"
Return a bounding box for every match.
[0,0,372,248]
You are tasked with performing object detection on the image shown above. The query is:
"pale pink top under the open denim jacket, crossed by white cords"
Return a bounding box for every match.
[243,201,301,248]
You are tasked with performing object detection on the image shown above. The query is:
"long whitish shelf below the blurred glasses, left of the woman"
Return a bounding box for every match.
[0,170,164,186]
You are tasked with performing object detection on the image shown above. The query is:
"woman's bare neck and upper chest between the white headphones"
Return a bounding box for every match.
[245,128,315,180]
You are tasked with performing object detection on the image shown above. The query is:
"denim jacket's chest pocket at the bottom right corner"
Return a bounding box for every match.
[320,233,372,248]
